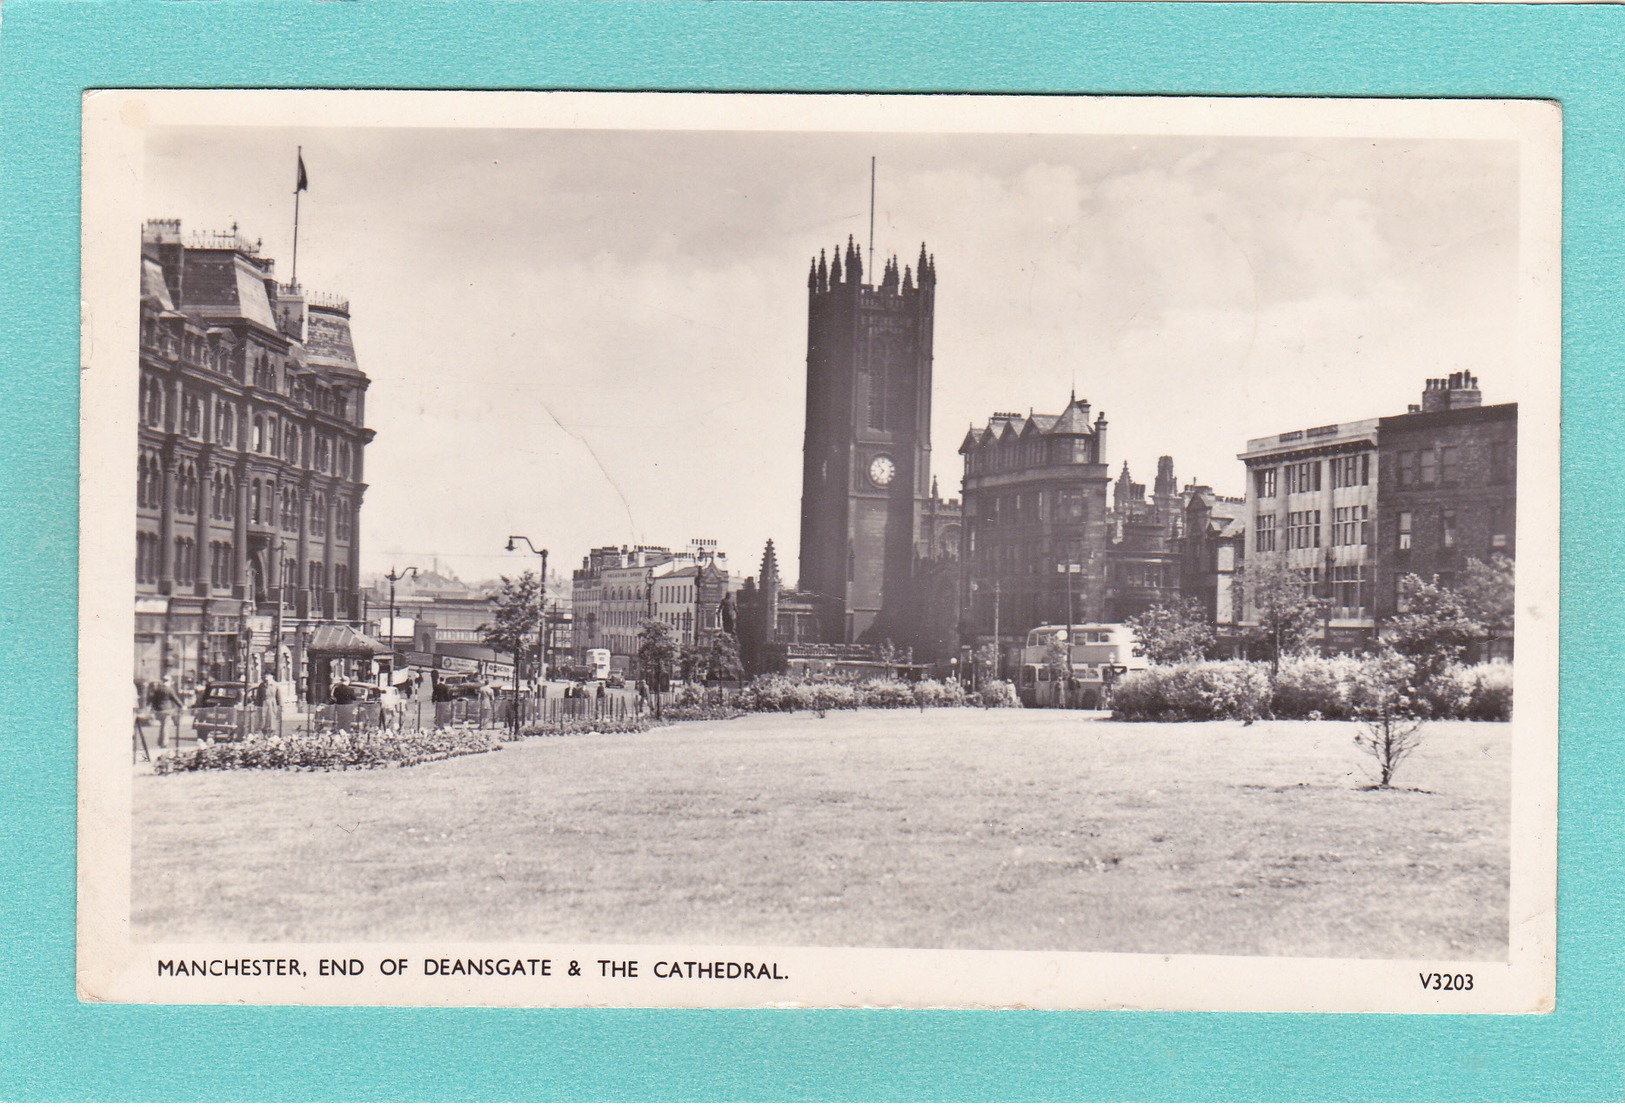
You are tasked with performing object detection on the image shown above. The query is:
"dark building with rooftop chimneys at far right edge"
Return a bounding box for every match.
[1373,372,1518,646]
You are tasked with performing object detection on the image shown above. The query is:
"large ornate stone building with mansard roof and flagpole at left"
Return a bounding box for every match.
[135,219,374,681]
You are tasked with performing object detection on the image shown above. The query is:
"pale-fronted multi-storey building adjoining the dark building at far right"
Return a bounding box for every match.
[1240,419,1380,649]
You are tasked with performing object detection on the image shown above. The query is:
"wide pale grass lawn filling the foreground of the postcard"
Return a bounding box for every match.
[132,709,1511,959]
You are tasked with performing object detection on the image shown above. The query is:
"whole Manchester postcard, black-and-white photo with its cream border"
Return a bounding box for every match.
[80,89,1560,1013]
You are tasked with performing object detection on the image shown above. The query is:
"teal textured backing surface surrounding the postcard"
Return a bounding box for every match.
[0,0,1625,1100]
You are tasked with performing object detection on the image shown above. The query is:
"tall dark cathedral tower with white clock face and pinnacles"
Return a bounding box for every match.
[801,237,936,642]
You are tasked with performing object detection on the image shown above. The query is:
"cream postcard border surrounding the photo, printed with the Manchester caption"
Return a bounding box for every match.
[78,89,1562,1013]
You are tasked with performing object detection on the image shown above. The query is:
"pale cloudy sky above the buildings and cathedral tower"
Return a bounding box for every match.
[143,119,1518,579]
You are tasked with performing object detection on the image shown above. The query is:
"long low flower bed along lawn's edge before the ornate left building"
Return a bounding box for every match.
[153,727,502,774]
